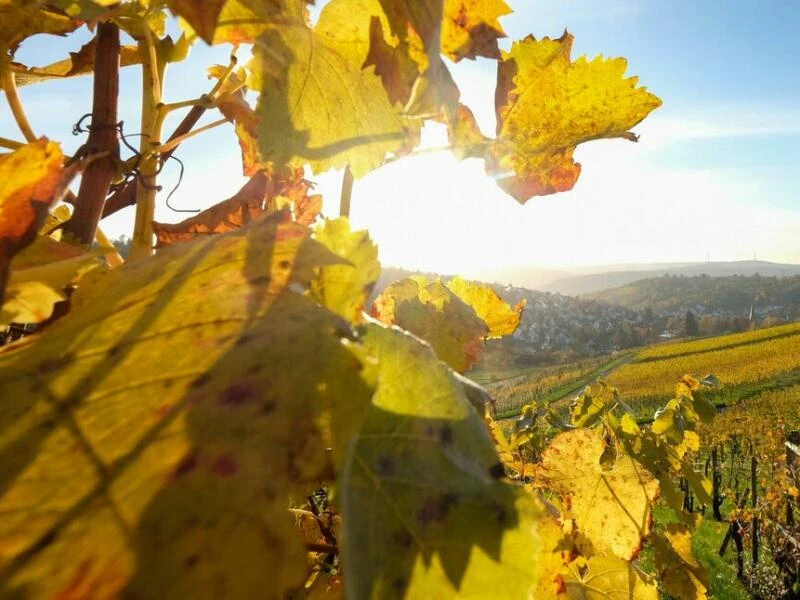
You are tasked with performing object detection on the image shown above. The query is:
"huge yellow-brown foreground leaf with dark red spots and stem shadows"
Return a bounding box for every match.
[0,215,363,598]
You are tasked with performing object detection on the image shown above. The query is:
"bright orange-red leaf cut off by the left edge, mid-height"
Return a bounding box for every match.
[0,138,64,302]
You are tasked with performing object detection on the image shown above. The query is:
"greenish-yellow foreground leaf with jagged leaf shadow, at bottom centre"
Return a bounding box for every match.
[339,324,555,598]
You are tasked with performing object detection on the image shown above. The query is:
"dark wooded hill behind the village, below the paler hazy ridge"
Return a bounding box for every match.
[584,268,800,313]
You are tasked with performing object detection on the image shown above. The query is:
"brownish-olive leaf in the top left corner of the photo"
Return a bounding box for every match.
[0,0,76,55]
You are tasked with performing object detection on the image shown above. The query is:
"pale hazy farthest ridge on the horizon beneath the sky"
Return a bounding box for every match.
[537,260,800,296]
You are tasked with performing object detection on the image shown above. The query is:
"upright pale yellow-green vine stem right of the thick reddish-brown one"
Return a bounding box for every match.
[130,27,166,260]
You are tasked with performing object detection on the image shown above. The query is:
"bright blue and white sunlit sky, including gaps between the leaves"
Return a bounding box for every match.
[0,0,800,277]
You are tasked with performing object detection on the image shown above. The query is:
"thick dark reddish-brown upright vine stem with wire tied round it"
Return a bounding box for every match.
[64,21,120,245]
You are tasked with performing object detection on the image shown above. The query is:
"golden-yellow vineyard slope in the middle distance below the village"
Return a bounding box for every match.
[488,323,800,421]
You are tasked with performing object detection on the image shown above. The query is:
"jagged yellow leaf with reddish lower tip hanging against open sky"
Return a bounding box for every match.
[486,32,661,203]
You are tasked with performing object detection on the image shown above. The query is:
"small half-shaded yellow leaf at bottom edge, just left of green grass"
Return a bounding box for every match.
[653,523,708,600]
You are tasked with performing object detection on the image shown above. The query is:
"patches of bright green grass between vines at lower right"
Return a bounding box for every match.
[639,506,750,600]
